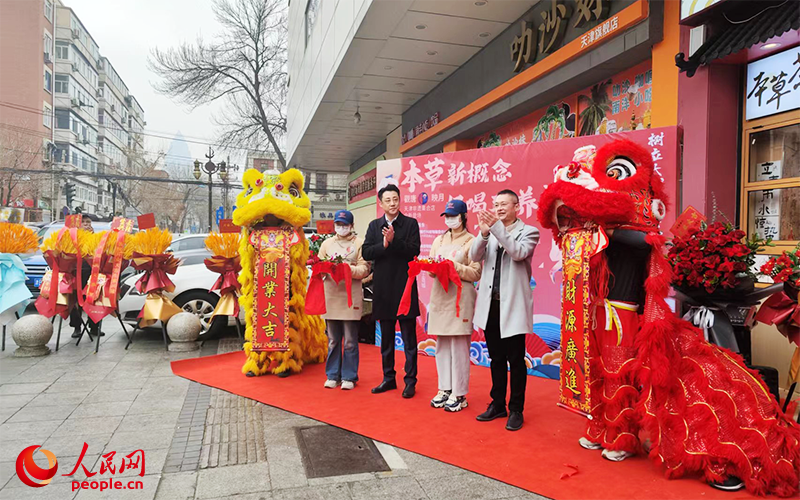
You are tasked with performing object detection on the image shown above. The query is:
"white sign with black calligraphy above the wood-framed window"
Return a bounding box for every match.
[746,48,800,120]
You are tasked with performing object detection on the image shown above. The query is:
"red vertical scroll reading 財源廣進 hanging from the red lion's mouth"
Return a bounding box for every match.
[558,230,593,415]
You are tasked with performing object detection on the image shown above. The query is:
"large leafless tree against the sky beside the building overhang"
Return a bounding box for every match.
[149,0,288,168]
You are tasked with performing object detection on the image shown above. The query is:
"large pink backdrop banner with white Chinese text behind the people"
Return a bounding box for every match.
[378,127,680,379]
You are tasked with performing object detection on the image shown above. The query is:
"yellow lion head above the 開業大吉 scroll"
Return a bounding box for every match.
[233,168,311,229]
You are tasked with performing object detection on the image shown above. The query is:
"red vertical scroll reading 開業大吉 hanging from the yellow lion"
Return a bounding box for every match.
[250,228,294,352]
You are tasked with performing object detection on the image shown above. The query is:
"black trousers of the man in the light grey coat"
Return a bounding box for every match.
[483,299,528,412]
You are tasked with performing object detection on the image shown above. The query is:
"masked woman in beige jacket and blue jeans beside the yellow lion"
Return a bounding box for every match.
[318,210,369,390]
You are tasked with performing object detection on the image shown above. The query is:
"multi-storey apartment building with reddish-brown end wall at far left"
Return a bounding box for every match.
[0,0,145,217]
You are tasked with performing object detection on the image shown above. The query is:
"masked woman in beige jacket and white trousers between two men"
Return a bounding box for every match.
[428,200,481,412]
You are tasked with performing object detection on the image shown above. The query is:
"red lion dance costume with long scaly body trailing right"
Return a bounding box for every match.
[538,141,800,496]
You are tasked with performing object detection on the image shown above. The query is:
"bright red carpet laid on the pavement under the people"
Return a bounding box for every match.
[172,344,753,500]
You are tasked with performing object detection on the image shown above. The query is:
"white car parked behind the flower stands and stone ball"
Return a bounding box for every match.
[119,251,244,340]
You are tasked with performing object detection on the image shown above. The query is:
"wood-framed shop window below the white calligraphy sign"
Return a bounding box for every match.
[741,112,800,254]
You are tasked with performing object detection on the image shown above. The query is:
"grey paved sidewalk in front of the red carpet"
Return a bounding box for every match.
[0,316,545,500]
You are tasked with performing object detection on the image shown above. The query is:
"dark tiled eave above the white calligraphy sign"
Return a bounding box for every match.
[675,0,800,77]
